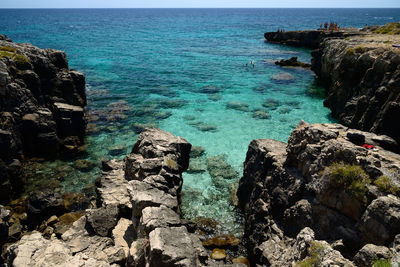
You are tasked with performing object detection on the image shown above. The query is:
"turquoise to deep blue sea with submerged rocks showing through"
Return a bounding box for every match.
[0,9,400,235]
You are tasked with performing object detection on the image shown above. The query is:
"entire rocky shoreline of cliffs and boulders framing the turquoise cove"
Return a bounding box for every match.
[0,23,400,267]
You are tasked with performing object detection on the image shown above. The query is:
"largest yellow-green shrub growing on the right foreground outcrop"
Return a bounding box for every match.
[324,162,371,203]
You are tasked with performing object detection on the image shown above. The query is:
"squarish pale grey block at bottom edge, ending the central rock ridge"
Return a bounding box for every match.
[149,226,207,267]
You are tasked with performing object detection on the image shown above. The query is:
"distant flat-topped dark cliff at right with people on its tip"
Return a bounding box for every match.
[265,25,400,148]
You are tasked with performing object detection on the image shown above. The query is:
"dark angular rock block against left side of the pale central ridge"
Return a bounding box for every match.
[86,205,118,237]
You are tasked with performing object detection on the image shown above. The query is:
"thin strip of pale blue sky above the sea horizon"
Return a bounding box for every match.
[0,0,400,8]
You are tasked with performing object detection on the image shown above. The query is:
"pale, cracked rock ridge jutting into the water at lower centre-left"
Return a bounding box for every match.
[7,128,246,267]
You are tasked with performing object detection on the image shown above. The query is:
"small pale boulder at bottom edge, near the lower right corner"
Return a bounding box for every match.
[354,244,392,266]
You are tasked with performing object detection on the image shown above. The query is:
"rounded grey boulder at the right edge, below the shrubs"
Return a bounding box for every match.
[360,196,400,245]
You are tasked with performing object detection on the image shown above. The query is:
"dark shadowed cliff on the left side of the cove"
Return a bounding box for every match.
[0,35,86,203]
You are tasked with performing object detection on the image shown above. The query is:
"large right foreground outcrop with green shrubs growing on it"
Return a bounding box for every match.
[237,122,400,266]
